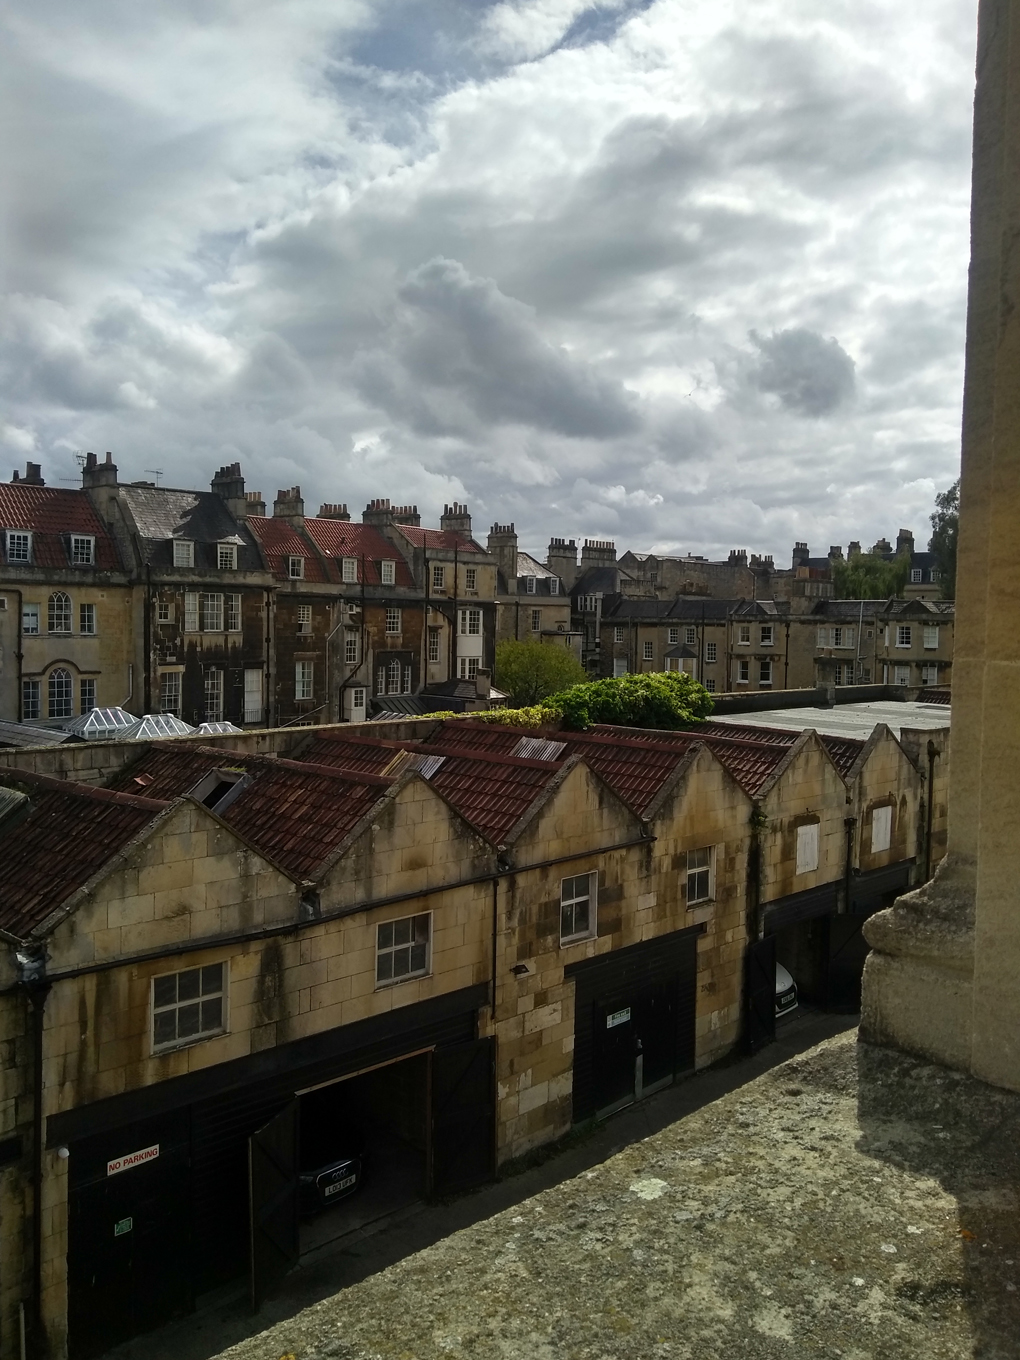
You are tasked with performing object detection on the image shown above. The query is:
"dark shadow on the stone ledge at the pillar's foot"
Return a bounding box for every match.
[857,1043,1020,1360]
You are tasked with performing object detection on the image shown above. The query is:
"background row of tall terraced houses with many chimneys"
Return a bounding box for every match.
[0,454,953,726]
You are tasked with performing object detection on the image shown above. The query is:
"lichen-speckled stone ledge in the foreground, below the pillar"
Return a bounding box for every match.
[213,1032,1020,1360]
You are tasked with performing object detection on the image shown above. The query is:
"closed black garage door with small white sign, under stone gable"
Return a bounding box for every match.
[564,926,702,1122]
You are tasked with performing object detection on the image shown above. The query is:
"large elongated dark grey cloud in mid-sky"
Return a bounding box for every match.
[360,258,639,438]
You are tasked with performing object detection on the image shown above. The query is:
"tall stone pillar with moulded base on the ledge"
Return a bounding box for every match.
[861,0,1020,1091]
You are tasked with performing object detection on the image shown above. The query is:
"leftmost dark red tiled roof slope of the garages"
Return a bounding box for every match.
[0,770,166,938]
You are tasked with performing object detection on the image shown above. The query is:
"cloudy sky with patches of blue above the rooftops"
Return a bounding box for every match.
[0,0,976,563]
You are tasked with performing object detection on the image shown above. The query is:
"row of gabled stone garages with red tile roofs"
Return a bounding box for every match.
[0,701,948,1360]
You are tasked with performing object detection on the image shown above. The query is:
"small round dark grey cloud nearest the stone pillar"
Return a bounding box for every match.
[749,326,854,416]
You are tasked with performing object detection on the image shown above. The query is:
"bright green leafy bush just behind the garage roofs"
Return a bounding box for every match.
[545,670,713,732]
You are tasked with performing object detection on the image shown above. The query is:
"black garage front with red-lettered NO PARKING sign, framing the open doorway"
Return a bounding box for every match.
[61,989,495,1360]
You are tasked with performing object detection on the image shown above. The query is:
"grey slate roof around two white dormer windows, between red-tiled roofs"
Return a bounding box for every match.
[120,483,265,571]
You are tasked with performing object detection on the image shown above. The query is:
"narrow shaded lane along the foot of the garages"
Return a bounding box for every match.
[110,1009,857,1360]
